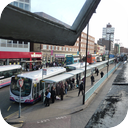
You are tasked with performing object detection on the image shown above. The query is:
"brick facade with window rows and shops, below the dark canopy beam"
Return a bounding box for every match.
[41,32,95,62]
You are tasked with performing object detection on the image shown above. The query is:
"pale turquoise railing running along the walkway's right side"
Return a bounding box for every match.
[85,63,120,102]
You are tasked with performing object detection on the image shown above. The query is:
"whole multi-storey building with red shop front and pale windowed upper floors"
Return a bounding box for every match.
[0,0,42,65]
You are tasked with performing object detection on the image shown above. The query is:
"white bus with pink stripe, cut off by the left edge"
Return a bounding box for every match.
[0,65,22,88]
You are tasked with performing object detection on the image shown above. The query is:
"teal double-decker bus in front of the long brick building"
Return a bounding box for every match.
[66,55,80,65]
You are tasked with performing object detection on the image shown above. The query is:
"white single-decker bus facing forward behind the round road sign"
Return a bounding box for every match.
[10,67,66,104]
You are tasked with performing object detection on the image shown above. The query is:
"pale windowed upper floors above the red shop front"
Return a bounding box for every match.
[0,0,31,52]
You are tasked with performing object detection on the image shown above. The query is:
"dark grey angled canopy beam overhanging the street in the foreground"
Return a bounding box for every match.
[0,0,101,46]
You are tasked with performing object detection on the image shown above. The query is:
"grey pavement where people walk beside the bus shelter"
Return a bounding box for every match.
[0,64,121,128]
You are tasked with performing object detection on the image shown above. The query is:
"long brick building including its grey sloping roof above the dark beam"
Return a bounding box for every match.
[30,12,95,62]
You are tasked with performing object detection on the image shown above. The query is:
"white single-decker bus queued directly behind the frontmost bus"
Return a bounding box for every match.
[64,62,89,72]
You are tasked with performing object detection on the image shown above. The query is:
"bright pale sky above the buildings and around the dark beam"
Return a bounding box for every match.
[31,0,128,48]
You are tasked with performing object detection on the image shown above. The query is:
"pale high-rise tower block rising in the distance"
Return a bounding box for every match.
[102,23,115,42]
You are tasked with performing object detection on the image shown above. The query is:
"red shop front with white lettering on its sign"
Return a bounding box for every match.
[0,51,42,69]
